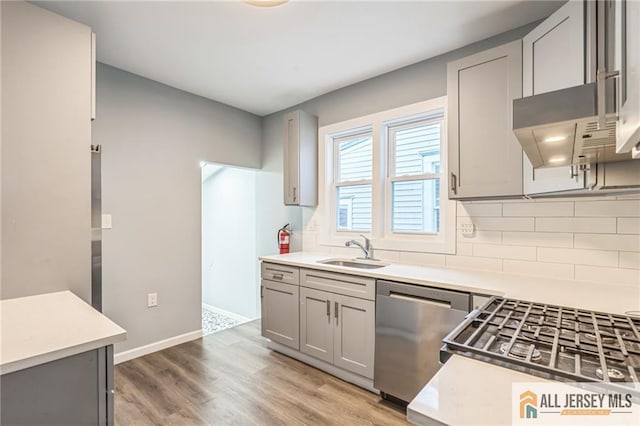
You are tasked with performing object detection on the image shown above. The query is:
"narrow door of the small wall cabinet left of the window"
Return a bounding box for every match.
[283,111,300,205]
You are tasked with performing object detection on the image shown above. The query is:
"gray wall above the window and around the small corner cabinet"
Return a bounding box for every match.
[256,23,537,262]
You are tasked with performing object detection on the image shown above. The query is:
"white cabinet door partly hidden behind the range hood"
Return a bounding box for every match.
[522,2,586,194]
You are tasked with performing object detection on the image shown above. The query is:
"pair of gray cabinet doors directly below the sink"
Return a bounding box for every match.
[300,273,375,378]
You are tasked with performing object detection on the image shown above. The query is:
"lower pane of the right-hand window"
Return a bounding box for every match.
[391,179,440,233]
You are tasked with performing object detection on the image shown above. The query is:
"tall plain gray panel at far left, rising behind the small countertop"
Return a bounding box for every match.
[0,2,91,301]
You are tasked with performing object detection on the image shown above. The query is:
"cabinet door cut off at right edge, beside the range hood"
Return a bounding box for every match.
[615,0,640,153]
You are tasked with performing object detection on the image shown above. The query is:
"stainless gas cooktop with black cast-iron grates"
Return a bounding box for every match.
[441,297,640,395]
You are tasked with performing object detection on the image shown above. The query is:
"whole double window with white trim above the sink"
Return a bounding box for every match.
[318,98,455,253]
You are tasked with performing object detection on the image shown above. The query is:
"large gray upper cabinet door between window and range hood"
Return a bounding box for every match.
[447,40,522,199]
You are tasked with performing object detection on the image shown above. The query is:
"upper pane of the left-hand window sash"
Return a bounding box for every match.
[337,135,373,182]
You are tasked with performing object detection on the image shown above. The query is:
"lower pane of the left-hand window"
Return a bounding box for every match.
[336,185,371,231]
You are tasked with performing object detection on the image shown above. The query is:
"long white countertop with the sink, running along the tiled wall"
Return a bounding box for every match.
[260,252,640,314]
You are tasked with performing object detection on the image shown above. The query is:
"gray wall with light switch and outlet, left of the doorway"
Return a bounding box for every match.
[93,64,262,352]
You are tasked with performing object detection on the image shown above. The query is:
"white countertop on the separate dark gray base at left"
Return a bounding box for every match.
[0,291,126,374]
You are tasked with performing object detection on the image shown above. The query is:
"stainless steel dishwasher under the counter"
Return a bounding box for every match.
[373,280,471,402]
